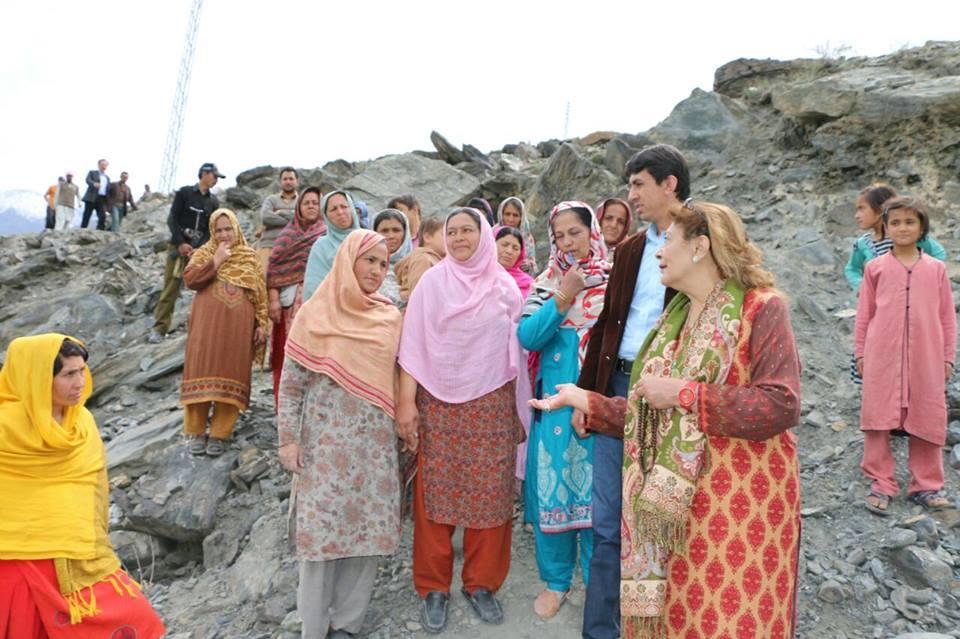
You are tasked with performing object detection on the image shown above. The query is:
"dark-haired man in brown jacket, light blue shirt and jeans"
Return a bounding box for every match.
[573,144,690,639]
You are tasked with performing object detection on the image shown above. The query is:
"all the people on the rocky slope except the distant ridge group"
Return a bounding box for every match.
[0,145,956,639]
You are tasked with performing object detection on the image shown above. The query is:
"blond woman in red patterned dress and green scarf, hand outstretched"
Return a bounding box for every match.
[532,201,800,638]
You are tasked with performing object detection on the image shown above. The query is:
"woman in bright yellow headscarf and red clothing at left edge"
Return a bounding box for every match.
[0,333,164,639]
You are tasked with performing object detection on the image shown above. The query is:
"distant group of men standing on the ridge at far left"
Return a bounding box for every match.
[43,159,144,232]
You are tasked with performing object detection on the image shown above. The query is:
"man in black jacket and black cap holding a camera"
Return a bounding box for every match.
[149,162,225,344]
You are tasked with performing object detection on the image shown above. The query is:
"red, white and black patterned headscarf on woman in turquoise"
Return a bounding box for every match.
[523,201,611,366]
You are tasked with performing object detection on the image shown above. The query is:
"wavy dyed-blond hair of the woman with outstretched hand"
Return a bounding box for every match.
[670,199,776,289]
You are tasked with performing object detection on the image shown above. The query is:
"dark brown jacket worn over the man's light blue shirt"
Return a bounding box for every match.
[577,231,676,437]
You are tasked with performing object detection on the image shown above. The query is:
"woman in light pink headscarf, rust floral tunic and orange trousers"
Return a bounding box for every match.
[397,208,529,632]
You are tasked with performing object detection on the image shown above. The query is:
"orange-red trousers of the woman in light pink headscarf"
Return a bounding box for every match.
[413,468,513,597]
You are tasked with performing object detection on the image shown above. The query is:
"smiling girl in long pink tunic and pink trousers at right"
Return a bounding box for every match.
[854,197,957,514]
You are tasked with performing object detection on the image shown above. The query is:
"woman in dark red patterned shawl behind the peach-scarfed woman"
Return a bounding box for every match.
[267,186,327,401]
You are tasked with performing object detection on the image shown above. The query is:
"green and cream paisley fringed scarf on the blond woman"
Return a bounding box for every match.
[620,280,746,638]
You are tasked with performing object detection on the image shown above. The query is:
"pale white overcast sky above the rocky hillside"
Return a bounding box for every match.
[0,0,960,194]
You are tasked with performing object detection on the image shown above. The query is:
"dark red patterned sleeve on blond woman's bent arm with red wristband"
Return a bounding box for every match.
[697,297,800,441]
